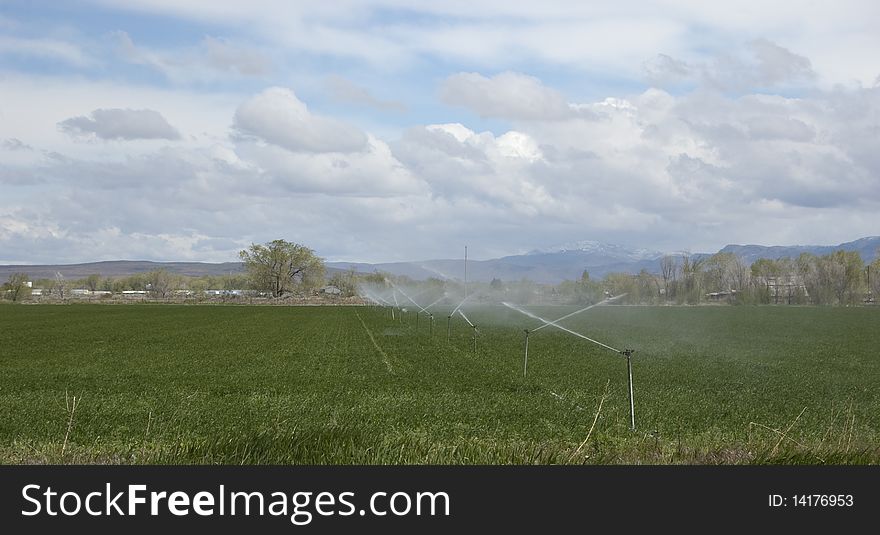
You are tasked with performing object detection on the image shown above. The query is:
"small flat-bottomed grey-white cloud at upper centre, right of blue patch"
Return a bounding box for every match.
[440,72,573,120]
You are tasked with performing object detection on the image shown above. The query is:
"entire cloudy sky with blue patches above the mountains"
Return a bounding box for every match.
[0,0,880,263]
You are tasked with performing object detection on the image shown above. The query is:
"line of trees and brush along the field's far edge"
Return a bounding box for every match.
[2,240,880,305]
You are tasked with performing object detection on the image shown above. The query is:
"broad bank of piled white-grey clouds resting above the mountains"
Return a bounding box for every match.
[0,63,880,261]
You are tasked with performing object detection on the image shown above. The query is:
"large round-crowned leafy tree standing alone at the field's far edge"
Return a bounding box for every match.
[239,240,324,297]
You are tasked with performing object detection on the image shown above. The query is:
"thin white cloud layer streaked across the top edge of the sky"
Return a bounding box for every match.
[82,0,880,88]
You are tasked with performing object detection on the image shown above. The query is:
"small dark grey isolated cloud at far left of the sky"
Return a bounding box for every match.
[58,108,180,140]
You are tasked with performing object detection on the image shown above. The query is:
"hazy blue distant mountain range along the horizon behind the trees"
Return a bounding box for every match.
[0,236,880,283]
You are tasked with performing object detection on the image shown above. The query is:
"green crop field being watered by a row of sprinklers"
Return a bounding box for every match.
[0,305,880,464]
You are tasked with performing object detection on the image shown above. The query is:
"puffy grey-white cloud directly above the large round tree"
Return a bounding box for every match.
[234,87,367,152]
